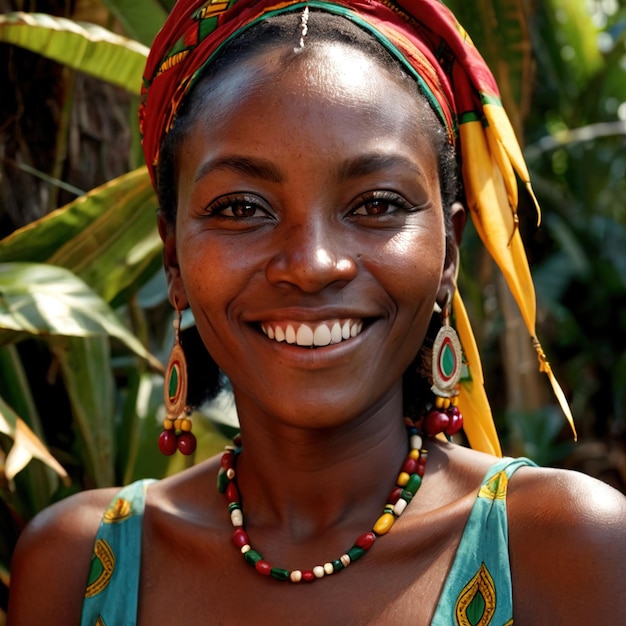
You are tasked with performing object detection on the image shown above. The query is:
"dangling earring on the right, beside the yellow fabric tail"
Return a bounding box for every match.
[422,293,463,436]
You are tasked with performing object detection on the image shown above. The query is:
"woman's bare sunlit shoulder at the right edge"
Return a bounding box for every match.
[507,468,626,626]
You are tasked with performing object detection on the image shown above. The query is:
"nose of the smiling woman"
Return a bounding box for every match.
[266,221,358,293]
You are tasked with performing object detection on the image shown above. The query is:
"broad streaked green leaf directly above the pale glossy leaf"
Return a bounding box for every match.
[0,167,162,303]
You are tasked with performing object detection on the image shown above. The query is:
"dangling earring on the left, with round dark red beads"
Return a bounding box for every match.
[159,307,196,456]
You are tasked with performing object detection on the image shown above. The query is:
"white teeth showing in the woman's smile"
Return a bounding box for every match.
[261,319,363,348]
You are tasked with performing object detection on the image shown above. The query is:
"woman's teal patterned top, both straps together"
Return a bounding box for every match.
[81,458,534,626]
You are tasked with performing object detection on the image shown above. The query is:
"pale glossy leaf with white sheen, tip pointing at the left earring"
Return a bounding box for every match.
[0,263,156,364]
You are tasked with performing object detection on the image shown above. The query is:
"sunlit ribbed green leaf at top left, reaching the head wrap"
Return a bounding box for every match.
[0,12,148,93]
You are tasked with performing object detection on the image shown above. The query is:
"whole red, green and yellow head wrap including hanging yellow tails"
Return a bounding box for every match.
[140,0,573,455]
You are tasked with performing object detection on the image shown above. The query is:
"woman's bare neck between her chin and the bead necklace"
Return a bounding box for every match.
[232,390,408,541]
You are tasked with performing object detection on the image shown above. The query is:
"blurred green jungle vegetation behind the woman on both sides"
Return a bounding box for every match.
[0,0,626,624]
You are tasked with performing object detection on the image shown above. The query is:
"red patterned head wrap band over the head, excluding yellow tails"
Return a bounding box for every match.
[140,0,499,182]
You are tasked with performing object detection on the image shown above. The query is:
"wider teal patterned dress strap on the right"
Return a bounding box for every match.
[431,458,535,626]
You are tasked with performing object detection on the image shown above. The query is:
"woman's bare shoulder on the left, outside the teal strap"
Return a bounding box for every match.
[8,489,117,626]
